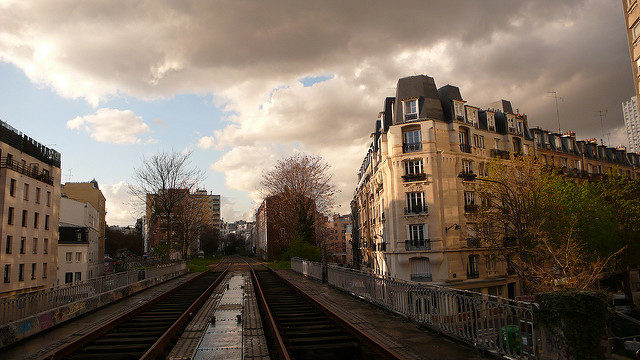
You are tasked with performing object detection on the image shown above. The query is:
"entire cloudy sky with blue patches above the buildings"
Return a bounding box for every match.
[0,0,634,225]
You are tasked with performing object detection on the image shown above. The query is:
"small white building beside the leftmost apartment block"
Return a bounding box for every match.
[58,197,102,285]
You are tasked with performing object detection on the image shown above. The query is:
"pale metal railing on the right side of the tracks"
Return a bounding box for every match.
[291,259,538,359]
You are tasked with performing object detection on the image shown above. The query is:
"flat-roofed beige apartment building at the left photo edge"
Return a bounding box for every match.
[0,122,61,296]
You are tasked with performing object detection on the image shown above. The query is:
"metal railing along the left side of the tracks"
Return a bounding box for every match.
[0,262,186,325]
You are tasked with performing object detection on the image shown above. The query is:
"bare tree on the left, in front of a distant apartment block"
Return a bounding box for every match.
[129,151,204,255]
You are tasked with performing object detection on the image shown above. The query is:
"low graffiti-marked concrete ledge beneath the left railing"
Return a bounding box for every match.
[0,268,187,348]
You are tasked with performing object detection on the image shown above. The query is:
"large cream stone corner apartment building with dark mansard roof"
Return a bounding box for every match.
[352,75,638,298]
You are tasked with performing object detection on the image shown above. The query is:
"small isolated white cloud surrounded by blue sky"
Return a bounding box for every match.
[67,108,154,144]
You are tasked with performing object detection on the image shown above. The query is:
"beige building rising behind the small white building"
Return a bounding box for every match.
[62,179,107,268]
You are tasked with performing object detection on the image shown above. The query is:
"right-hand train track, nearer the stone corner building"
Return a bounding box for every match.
[249,264,400,360]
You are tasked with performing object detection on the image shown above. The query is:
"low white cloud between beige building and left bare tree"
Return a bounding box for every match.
[100,181,142,226]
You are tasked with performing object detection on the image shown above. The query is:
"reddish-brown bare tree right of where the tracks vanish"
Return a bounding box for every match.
[261,154,336,252]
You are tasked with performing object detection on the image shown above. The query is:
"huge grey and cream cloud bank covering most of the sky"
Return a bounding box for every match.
[0,0,633,214]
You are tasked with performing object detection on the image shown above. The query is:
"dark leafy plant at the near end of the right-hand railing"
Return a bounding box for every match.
[536,289,608,360]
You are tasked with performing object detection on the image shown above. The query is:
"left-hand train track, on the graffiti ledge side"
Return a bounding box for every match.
[48,264,230,359]
